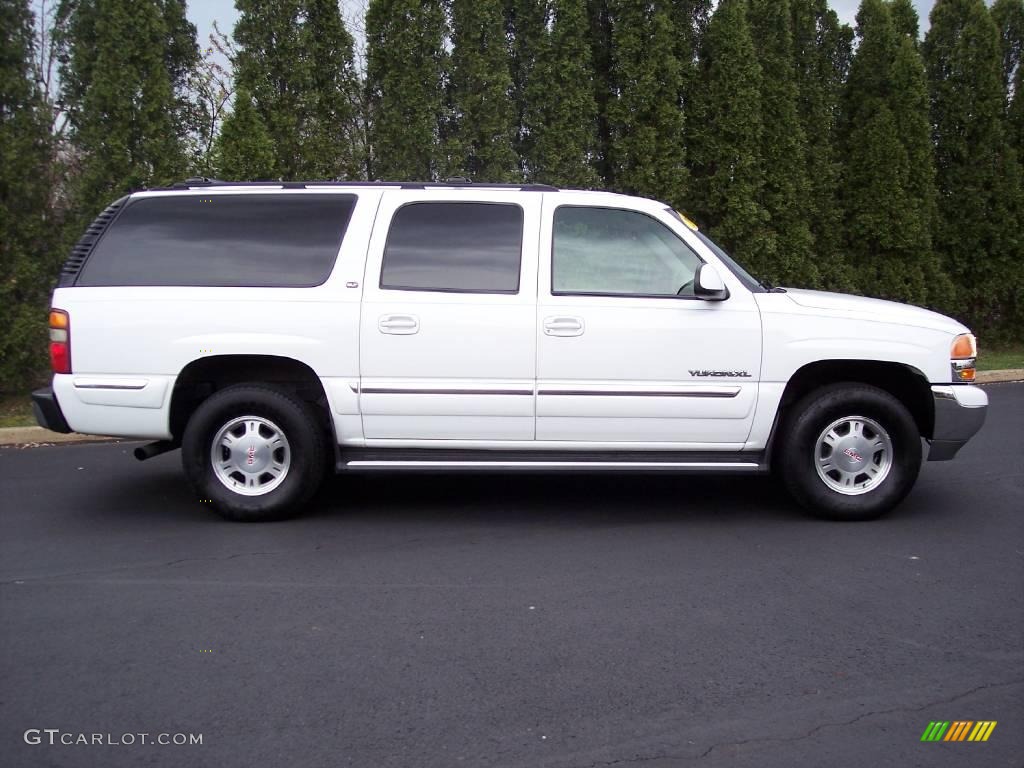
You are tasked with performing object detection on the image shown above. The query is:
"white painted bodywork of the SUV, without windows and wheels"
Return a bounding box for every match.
[53,186,983,452]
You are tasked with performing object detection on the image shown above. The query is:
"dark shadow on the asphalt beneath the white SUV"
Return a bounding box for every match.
[76,455,943,526]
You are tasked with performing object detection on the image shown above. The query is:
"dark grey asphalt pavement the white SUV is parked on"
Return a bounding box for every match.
[0,384,1024,768]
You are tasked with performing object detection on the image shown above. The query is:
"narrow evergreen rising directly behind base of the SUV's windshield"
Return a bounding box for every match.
[750,0,820,288]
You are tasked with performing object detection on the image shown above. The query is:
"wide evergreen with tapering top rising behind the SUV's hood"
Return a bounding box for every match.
[840,0,946,304]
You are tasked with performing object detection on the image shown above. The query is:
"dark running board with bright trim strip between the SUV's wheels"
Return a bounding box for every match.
[337,449,768,474]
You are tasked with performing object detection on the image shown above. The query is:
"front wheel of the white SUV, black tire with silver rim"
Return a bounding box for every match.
[775,383,922,520]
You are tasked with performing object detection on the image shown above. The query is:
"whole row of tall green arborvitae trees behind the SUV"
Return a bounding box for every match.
[0,0,1024,389]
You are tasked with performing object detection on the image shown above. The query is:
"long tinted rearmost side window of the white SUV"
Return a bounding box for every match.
[76,195,355,288]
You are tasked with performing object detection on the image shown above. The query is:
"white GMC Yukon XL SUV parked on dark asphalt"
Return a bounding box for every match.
[34,179,987,520]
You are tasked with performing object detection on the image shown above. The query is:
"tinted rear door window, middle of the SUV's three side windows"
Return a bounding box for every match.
[380,202,523,294]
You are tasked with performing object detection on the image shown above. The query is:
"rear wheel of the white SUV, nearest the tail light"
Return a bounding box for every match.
[181,384,327,522]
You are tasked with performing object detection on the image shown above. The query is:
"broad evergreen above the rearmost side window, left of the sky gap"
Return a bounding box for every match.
[234,0,359,179]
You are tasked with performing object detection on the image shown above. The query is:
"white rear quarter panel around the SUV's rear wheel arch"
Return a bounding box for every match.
[46,191,380,439]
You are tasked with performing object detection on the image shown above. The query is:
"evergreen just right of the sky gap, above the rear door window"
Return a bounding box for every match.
[367,0,445,181]
